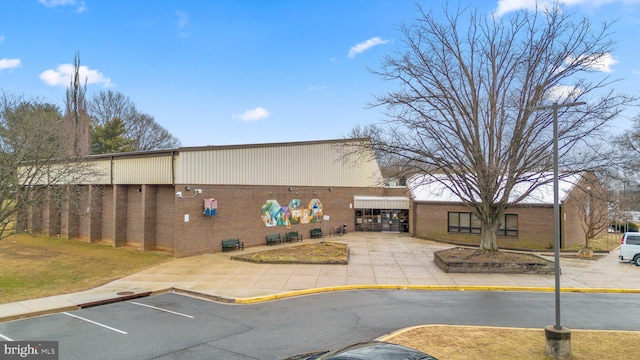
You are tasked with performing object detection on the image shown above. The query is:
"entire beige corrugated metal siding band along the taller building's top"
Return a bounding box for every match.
[25,141,383,187]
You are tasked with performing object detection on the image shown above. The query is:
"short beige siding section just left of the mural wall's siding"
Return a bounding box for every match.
[112,155,172,184]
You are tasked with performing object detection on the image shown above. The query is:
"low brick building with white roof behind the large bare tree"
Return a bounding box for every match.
[409,173,608,249]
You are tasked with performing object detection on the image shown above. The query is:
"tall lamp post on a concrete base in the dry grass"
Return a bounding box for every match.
[530,102,586,359]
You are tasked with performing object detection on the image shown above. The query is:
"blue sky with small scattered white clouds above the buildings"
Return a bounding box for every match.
[0,0,640,146]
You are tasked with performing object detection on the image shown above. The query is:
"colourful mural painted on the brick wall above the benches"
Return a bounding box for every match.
[261,199,322,228]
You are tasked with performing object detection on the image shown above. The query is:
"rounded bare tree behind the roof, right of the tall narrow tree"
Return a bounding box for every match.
[89,90,180,151]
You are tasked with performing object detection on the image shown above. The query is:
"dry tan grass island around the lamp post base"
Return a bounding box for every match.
[385,325,640,360]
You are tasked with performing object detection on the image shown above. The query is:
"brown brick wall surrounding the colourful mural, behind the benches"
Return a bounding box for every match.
[174,185,384,257]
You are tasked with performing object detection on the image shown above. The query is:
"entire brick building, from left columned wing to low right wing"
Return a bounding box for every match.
[16,139,604,257]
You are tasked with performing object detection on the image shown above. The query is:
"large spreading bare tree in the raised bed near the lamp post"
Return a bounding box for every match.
[351,5,635,252]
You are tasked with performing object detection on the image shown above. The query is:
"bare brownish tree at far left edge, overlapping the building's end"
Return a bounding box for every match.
[0,92,96,239]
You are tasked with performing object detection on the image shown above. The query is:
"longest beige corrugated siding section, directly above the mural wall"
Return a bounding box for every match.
[176,143,382,187]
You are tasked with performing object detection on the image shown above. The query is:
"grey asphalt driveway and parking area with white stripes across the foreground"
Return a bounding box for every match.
[0,290,640,360]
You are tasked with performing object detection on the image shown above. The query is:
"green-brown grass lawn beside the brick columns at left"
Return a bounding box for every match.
[0,234,173,304]
